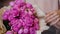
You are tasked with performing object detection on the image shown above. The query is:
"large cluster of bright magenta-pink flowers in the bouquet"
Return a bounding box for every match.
[3,0,39,34]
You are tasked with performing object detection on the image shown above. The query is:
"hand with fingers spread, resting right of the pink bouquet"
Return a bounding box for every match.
[45,11,60,25]
